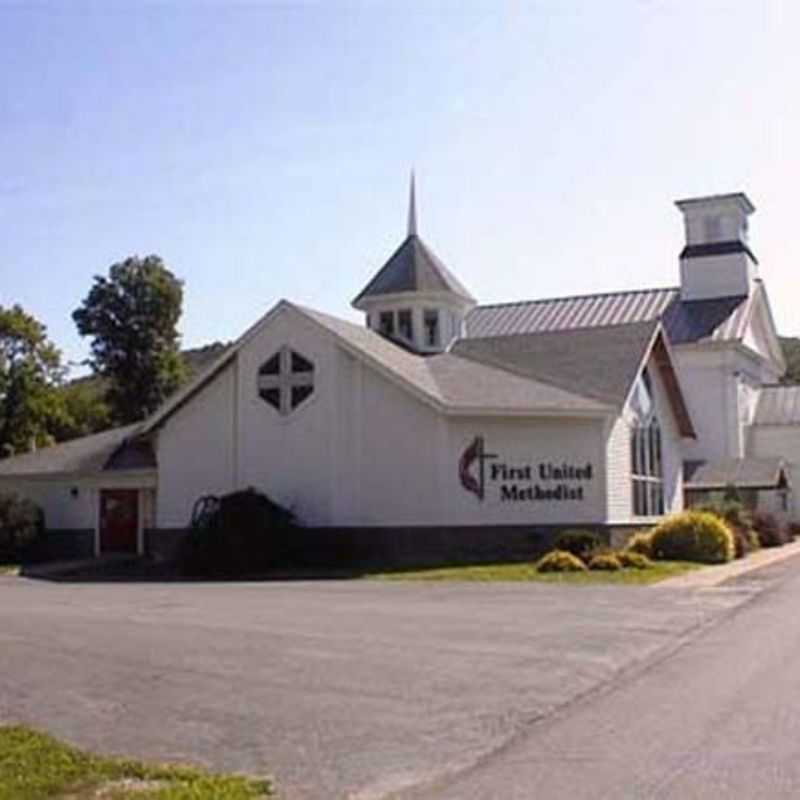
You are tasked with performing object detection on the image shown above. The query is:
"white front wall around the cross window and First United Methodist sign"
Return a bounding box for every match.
[152,310,620,527]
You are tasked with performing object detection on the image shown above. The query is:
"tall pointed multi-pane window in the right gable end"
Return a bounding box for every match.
[631,370,664,517]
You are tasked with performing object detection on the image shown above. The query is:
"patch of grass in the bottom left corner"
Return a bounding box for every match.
[0,726,273,800]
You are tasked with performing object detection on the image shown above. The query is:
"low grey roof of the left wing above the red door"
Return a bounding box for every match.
[0,424,155,478]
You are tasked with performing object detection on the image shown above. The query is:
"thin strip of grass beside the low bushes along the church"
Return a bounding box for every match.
[368,561,701,586]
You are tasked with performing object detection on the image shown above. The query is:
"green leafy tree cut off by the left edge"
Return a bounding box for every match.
[0,305,64,457]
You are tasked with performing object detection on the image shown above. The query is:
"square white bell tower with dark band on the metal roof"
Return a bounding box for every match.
[675,192,758,300]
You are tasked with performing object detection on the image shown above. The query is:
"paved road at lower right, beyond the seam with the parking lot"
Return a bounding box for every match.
[406,559,800,800]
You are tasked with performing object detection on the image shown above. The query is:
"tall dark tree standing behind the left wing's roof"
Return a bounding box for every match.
[72,255,186,424]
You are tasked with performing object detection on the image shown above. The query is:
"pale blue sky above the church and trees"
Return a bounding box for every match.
[0,0,800,372]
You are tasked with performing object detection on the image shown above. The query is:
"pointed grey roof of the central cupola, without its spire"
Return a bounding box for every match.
[353,233,475,308]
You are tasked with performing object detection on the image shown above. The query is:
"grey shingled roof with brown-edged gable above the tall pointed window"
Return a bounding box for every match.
[451,320,695,436]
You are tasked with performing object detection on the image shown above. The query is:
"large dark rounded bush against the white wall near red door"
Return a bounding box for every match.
[178,489,294,577]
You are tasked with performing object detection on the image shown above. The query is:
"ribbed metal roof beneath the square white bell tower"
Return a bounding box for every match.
[467,287,755,344]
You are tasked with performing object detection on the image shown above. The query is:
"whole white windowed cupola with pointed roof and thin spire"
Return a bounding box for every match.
[353,177,476,354]
